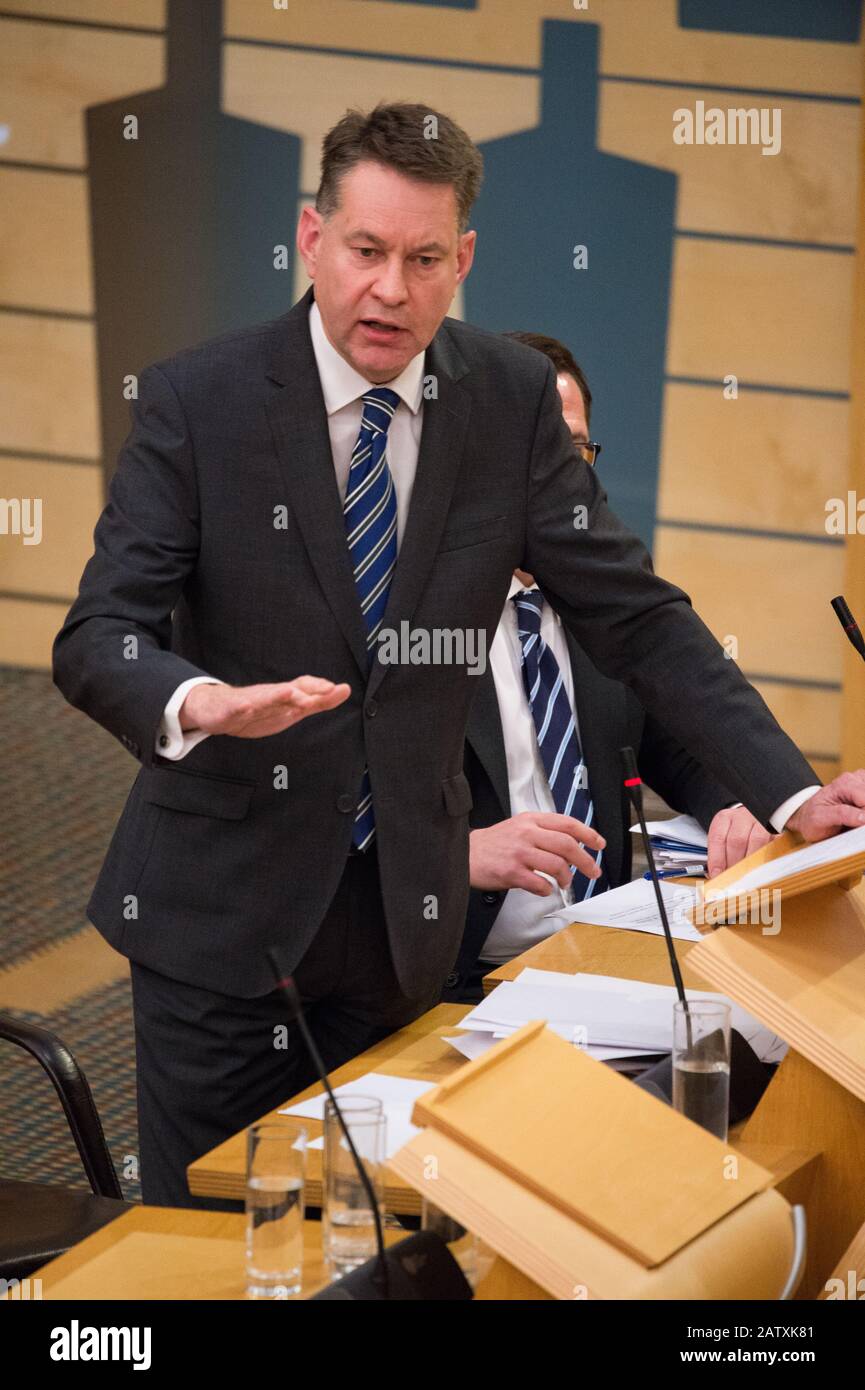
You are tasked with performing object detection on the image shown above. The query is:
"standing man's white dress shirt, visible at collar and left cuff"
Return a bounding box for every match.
[156,300,424,762]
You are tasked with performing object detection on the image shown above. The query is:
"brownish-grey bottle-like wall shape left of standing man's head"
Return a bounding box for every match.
[86,0,300,482]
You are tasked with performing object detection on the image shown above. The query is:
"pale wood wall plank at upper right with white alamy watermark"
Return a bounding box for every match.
[598,82,861,245]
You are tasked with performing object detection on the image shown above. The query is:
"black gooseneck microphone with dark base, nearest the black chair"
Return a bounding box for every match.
[267,951,473,1301]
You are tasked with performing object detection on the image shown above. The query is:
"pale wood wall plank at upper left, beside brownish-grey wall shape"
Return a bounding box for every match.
[0,19,165,168]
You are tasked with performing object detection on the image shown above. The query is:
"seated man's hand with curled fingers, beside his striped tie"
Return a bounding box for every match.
[469,810,606,898]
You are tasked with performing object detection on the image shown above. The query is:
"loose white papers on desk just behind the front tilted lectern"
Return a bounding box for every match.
[448,969,786,1063]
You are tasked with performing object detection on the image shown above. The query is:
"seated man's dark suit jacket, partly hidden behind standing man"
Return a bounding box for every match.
[442,614,736,1002]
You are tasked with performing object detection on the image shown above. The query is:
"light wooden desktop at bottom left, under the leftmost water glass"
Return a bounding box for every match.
[31,1207,406,1301]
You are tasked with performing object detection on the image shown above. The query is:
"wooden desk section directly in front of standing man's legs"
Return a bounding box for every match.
[186,1004,470,1215]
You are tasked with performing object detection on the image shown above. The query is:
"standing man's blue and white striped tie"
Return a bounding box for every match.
[343,386,399,849]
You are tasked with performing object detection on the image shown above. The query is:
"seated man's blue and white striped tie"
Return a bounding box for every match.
[513,589,609,902]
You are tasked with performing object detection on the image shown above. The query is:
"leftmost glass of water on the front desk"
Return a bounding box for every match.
[246,1116,306,1298]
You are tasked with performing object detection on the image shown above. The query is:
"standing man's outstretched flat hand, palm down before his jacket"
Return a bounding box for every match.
[181,676,352,738]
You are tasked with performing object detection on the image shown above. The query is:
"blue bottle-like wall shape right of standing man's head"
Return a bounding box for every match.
[466,21,676,545]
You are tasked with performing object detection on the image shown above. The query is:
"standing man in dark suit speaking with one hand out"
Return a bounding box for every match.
[54,104,865,1205]
